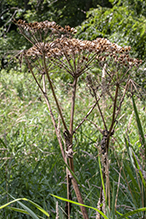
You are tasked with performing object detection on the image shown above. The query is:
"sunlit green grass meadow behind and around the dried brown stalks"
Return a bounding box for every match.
[0,70,146,219]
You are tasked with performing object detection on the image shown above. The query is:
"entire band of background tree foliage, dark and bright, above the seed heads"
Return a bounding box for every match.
[0,0,146,68]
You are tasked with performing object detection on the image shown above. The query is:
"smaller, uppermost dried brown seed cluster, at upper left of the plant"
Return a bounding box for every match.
[14,19,76,34]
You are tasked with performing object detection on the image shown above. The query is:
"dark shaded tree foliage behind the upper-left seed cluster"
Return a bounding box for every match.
[0,0,111,68]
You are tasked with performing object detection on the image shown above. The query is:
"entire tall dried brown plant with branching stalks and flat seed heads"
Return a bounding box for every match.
[15,20,142,218]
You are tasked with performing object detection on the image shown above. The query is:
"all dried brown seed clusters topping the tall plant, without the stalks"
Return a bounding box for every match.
[14,20,142,66]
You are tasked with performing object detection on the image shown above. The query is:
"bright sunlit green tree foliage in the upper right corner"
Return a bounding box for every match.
[78,0,146,59]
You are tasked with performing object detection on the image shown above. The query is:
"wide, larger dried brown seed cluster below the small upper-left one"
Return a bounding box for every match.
[26,37,142,66]
